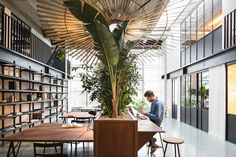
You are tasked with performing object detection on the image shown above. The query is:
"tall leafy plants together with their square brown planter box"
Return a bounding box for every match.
[61,0,163,157]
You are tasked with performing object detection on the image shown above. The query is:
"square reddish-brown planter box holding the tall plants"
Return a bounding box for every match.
[94,116,138,157]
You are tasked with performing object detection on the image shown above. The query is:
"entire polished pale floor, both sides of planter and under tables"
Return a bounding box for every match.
[0,119,236,157]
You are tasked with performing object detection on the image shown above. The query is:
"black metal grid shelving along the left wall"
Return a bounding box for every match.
[0,62,68,137]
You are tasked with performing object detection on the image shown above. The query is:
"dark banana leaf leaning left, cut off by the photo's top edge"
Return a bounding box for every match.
[64,0,109,28]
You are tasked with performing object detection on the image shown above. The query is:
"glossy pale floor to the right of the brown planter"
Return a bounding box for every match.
[139,119,236,157]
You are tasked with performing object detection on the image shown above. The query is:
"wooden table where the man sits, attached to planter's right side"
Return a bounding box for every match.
[138,119,165,152]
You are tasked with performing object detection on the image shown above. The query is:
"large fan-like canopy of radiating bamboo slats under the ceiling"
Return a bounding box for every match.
[37,0,199,63]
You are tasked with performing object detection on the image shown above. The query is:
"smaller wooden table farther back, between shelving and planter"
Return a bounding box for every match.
[59,112,93,123]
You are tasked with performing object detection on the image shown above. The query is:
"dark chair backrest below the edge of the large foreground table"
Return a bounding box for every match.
[33,143,63,157]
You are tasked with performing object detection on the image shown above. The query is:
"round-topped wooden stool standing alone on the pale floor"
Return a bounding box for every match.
[163,137,184,157]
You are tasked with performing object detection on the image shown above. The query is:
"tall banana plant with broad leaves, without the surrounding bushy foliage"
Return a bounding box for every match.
[64,0,134,118]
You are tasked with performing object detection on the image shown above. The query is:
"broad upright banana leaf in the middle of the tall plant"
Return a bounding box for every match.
[94,20,120,66]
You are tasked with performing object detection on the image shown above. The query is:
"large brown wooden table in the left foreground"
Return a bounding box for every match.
[0,123,93,157]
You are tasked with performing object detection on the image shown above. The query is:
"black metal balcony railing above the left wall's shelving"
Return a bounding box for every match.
[0,6,70,72]
